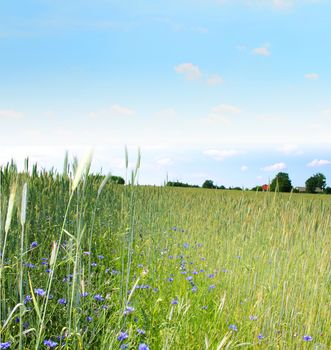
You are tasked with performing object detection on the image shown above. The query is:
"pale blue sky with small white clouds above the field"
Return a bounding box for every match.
[0,0,331,187]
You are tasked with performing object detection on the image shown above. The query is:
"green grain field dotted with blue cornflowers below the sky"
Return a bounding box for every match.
[0,159,331,350]
